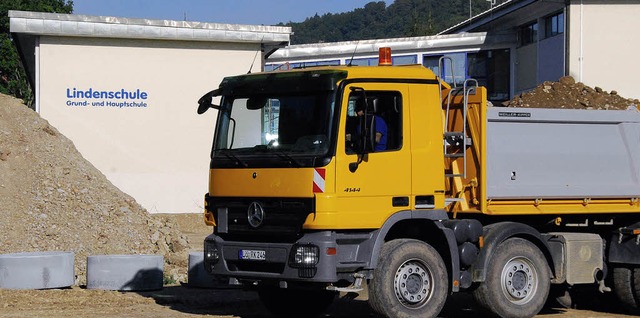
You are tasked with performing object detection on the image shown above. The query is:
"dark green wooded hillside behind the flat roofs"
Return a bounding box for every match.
[280,0,504,44]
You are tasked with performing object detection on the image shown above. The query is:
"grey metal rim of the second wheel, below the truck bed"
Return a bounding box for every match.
[501,257,539,304]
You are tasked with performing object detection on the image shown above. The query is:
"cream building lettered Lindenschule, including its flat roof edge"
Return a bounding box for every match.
[9,11,291,213]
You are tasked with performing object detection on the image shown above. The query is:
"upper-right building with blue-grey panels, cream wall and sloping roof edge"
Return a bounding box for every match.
[440,0,640,98]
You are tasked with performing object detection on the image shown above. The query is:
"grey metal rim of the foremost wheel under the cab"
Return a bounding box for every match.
[393,259,433,308]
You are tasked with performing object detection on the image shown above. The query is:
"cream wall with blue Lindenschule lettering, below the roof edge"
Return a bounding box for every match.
[36,36,261,213]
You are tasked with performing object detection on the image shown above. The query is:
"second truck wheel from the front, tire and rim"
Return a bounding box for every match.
[473,238,551,318]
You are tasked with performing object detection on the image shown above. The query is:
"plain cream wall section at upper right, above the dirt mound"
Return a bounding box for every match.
[568,0,640,98]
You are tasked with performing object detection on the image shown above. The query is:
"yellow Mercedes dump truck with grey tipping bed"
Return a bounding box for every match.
[198,50,640,317]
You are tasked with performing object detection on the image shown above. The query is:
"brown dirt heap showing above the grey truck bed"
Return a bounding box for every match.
[502,76,640,110]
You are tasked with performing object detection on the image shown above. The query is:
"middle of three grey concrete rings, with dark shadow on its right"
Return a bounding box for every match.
[87,255,164,291]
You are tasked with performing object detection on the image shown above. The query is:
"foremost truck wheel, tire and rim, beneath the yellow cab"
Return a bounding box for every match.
[369,239,449,318]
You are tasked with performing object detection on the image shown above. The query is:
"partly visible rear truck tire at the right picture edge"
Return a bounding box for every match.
[613,267,640,314]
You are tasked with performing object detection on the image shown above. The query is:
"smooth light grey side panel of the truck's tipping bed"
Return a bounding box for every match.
[486,107,640,199]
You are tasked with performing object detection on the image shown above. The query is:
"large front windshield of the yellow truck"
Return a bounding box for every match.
[212,91,334,167]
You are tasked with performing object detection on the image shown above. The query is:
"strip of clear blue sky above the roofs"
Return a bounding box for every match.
[73,0,393,25]
